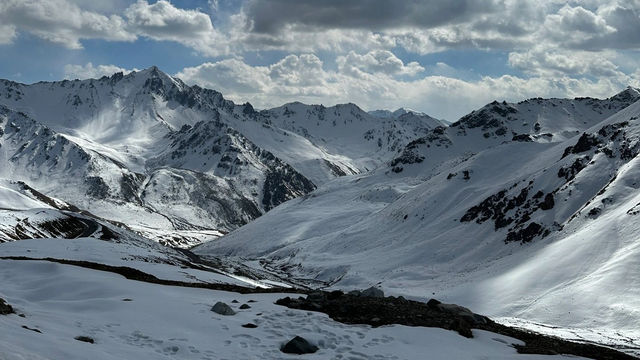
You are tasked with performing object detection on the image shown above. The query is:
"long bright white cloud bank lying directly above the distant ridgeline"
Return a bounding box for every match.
[176,54,638,120]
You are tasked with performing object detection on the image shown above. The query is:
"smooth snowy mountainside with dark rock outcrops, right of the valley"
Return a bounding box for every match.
[194,88,640,335]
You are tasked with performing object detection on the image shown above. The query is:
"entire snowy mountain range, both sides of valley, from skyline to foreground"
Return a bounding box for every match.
[0,67,640,352]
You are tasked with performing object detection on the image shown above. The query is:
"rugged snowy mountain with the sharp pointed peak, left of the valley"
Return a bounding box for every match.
[0,67,440,246]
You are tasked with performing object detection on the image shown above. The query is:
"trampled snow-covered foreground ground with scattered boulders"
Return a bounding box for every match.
[0,260,592,360]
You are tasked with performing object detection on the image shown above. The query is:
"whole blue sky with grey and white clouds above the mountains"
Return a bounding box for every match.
[0,0,640,120]
